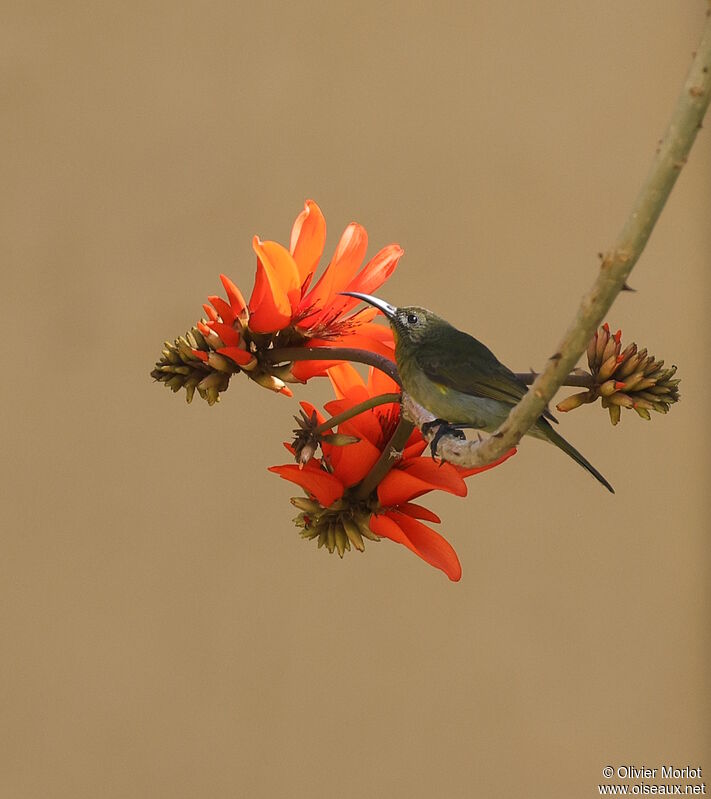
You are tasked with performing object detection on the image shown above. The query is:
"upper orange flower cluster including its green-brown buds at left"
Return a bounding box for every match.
[151,200,402,405]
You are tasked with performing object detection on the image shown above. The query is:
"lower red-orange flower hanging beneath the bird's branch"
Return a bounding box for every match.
[270,363,516,580]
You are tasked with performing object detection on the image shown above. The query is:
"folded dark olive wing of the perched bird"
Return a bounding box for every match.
[415,331,556,421]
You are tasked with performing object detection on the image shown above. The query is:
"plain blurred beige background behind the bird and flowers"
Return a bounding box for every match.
[0,0,711,799]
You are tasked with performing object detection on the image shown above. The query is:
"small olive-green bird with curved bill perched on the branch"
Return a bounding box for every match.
[342,291,615,494]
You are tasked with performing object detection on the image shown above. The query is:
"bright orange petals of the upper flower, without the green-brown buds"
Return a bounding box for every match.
[197,200,403,382]
